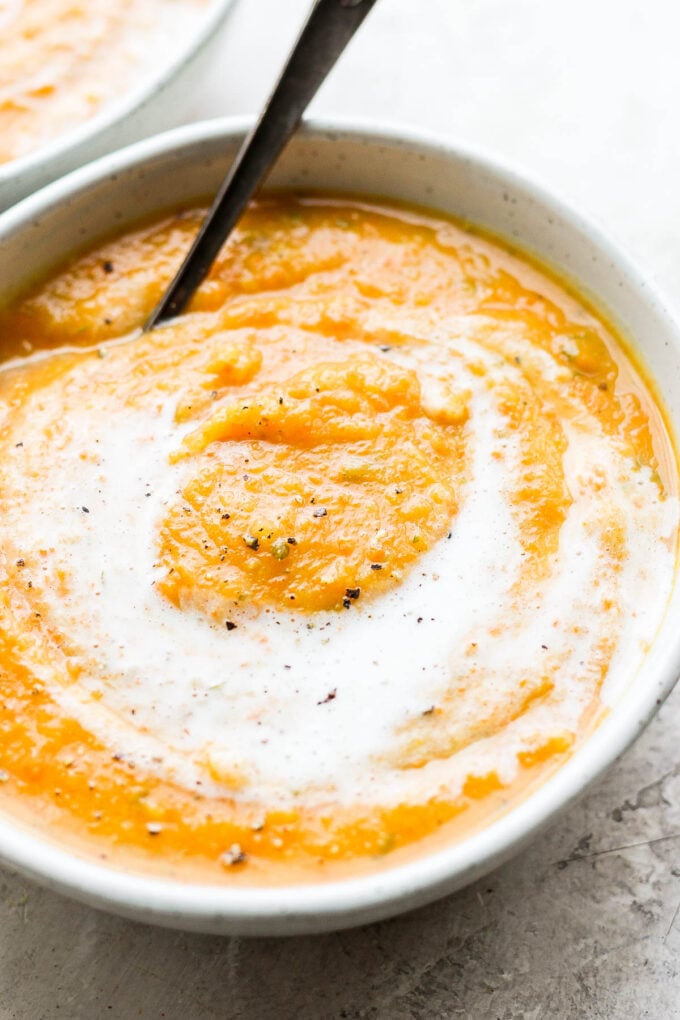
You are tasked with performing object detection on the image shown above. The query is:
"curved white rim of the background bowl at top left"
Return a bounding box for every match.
[0,0,236,189]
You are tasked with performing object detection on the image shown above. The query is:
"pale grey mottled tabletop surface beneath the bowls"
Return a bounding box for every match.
[0,0,680,1020]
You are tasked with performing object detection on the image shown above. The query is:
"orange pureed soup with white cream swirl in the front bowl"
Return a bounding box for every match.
[0,197,678,883]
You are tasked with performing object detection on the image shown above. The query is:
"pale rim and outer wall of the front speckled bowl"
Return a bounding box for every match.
[0,117,680,934]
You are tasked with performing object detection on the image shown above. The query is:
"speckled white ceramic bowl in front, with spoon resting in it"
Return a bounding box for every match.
[0,121,680,934]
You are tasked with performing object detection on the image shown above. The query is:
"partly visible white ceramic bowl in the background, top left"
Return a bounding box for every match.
[0,0,233,211]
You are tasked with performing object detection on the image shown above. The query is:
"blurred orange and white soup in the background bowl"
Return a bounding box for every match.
[0,0,206,163]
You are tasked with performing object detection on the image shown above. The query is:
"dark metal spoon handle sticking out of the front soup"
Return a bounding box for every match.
[145,0,375,332]
